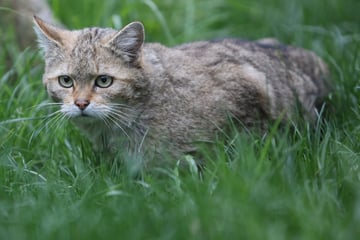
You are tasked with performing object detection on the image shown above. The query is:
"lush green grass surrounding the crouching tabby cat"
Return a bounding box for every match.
[0,0,360,240]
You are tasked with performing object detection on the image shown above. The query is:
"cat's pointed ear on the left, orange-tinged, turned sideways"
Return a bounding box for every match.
[34,16,66,52]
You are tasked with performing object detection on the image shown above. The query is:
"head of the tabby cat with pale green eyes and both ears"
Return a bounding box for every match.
[34,16,148,122]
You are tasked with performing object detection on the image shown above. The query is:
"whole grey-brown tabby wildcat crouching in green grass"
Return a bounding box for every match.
[34,16,329,168]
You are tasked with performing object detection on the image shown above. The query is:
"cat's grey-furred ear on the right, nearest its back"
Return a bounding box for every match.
[105,22,144,62]
